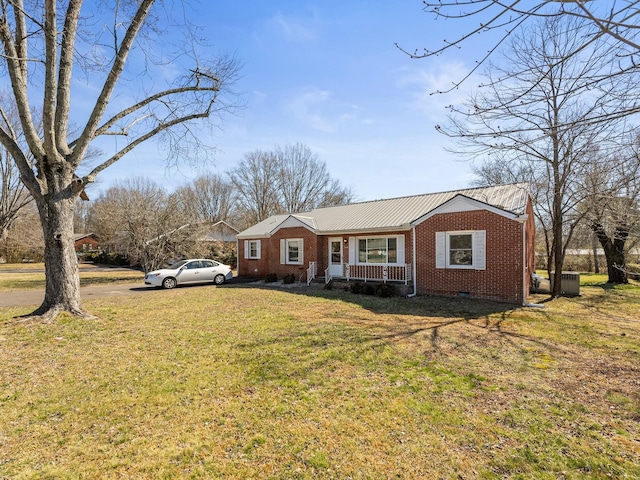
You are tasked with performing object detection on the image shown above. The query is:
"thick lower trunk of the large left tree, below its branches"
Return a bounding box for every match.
[32,198,90,321]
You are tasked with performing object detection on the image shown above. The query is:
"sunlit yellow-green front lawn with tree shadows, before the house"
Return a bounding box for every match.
[0,286,640,479]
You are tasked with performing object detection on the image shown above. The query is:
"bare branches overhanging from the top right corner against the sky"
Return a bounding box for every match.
[410,0,640,96]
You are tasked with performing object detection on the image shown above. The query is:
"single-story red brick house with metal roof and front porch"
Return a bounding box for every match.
[237,183,535,303]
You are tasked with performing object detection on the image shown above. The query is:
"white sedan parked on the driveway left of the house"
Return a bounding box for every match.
[144,258,233,288]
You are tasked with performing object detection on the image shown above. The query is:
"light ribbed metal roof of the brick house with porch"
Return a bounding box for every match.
[238,183,529,238]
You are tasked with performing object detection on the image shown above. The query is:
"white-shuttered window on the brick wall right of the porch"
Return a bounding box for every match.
[436,230,487,270]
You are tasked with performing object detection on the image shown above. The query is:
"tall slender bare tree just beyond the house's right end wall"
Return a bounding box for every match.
[440,17,638,296]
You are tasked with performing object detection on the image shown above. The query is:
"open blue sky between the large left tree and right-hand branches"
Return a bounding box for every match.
[90,0,488,200]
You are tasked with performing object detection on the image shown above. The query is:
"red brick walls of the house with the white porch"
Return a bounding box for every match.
[238,202,535,303]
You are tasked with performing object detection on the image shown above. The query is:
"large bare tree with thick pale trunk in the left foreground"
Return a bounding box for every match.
[0,0,238,320]
